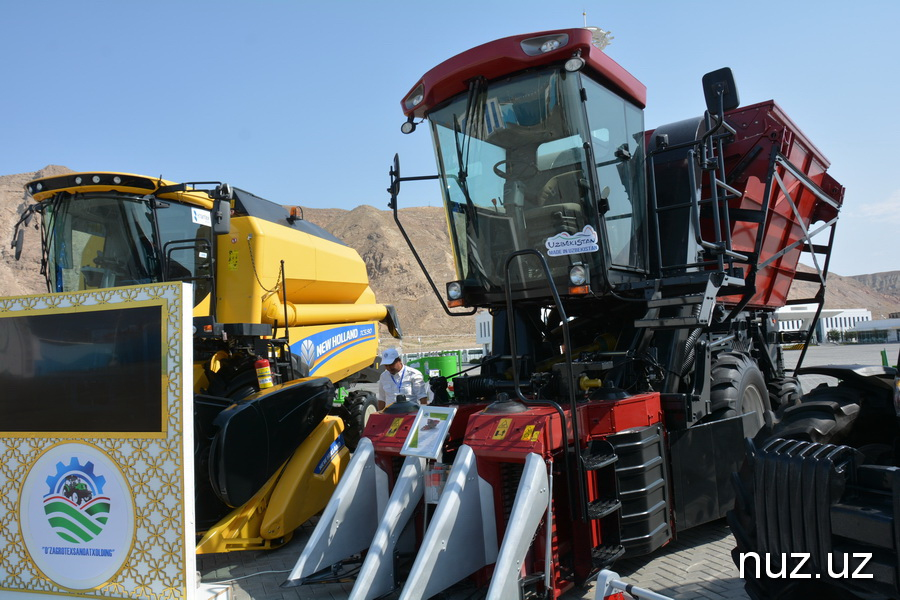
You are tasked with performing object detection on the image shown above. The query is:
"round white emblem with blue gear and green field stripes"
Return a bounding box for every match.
[19,442,134,590]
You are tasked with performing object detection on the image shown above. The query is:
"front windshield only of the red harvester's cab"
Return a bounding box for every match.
[429,71,598,291]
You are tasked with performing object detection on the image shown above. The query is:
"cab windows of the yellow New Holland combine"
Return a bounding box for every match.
[43,194,211,304]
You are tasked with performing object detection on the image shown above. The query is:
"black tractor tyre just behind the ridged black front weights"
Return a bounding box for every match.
[768,385,860,444]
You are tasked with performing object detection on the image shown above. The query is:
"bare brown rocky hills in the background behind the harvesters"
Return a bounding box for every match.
[0,166,900,351]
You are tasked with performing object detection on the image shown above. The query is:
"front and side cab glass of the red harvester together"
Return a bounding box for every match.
[428,70,645,300]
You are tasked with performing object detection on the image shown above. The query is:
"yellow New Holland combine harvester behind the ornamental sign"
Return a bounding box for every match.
[14,172,400,553]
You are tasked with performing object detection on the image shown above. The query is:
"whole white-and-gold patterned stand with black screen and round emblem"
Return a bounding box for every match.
[0,282,197,600]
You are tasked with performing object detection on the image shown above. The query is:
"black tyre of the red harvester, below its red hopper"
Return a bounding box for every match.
[705,352,771,430]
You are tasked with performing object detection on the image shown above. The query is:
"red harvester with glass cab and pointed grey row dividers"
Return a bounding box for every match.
[288,29,844,600]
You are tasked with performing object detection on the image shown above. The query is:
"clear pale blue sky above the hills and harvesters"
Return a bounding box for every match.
[0,0,900,275]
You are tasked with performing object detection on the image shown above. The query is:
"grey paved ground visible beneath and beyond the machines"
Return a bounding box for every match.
[197,343,900,600]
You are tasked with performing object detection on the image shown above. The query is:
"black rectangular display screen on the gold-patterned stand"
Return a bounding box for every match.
[0,305,165,435]
